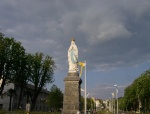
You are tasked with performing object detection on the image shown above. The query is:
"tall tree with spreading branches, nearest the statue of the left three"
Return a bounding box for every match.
[29,53,55,110]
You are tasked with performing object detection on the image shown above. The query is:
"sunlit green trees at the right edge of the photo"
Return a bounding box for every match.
[120,70,150,110]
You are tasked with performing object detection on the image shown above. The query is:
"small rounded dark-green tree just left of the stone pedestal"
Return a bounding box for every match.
[48,85,63,111]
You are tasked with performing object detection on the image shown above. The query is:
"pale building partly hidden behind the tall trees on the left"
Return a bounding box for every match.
[0,83,50,111]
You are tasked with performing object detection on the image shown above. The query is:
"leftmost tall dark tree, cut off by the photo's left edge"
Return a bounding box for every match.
[0,34,25,95]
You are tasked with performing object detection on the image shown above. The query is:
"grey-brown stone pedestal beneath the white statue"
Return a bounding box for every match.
[63,73,82,114]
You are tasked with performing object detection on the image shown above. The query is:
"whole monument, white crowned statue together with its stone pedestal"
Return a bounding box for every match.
[62,38,82,114]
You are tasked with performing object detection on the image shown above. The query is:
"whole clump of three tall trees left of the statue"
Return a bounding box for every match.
[0,33,55,110]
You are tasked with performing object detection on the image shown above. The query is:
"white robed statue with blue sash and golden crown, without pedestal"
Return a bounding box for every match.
[68,38,78,72]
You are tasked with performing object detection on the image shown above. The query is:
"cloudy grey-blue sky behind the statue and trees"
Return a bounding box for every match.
[0,0,150,99]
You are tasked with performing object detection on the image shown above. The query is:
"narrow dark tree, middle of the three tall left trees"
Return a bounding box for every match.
[13,53,30,109]
